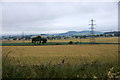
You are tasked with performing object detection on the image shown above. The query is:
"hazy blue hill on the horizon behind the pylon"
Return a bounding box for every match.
[57,31,103,36]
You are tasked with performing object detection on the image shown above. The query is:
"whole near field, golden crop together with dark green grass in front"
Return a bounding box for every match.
[2,44,120,79]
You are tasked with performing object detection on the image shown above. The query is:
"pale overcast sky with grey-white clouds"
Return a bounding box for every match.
[2,2,118,34]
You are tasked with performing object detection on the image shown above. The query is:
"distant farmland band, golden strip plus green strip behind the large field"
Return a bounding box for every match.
[0,37,120,46]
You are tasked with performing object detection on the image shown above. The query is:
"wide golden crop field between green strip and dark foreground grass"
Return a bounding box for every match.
[2,45,118,64]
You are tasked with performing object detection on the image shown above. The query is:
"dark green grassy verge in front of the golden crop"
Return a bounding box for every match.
[2,60,120,79]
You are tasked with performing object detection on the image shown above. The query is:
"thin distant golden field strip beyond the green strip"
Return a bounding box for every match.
[2,37,118,43]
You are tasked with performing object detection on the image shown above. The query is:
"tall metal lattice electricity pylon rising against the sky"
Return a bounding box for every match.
[89,19,96,43]
